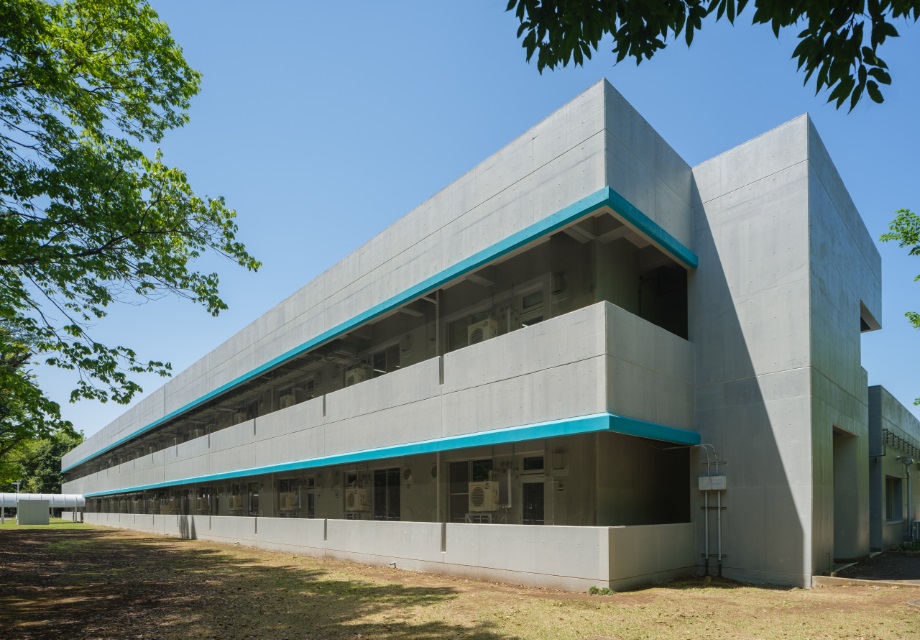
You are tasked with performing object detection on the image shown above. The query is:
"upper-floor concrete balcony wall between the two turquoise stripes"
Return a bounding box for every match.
[64,302,692,494]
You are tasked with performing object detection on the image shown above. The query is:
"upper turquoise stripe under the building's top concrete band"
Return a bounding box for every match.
[61,187,699,473]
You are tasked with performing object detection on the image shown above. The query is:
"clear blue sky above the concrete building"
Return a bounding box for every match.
[40,0,920,435]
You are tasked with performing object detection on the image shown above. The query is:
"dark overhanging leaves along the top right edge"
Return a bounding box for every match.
[508,0,920,109]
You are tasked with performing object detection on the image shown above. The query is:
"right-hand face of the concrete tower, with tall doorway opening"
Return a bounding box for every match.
[805,119,882,571]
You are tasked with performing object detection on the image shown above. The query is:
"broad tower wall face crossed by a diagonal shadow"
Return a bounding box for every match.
[690,117,813,586]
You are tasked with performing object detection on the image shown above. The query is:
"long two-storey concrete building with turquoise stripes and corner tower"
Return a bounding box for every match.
[63,81,920,589]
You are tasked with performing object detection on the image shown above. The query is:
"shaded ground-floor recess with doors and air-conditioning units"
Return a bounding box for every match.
[87,433,691,526]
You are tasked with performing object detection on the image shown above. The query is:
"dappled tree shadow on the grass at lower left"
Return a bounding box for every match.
[0,529,511,640]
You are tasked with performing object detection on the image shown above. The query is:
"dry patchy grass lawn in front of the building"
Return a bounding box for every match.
[0,523,920,640]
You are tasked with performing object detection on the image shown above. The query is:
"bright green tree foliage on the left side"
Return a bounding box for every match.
[0,0,259,455]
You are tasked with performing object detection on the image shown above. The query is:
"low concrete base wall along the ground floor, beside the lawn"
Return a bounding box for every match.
[85,513,697,591]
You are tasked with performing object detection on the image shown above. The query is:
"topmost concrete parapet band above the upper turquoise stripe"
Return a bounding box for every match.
[63,81,690,476]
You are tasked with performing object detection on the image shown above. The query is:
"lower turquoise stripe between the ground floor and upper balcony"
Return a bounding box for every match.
[84,413,701,498]
